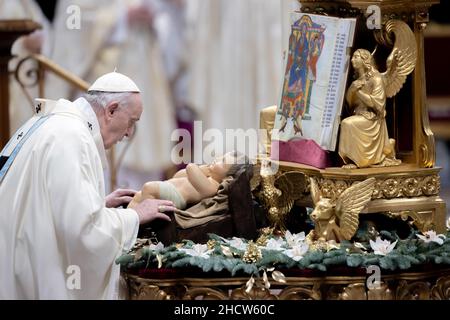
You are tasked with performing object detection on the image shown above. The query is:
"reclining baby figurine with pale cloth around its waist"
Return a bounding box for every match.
[128,152,246,210]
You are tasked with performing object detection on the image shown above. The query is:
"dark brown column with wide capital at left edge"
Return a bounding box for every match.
[0,20,41,149]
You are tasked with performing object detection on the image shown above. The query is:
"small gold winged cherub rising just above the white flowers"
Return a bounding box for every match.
[308,178,375,242]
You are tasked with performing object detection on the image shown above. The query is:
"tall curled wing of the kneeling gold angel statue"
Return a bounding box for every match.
[383,20,417,98]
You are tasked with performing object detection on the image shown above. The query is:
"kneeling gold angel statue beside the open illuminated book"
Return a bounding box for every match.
[339,20,417,168]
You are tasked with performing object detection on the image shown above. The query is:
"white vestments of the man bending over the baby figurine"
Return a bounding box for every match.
[0,71,174,299]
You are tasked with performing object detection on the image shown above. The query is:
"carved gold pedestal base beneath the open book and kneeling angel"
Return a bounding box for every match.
[260,162,446,233]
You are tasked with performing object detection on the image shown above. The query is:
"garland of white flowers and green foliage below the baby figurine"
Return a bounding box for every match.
[116,230,450,276]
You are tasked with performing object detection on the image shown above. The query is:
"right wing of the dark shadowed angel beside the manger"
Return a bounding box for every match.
[274,171,306,211]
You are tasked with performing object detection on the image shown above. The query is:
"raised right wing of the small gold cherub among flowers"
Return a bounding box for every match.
[336,178,376,240]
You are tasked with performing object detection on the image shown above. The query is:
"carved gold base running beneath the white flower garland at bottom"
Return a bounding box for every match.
[125,269,450,300]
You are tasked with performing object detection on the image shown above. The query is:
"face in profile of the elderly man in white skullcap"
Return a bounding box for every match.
[102,93,143,149]
